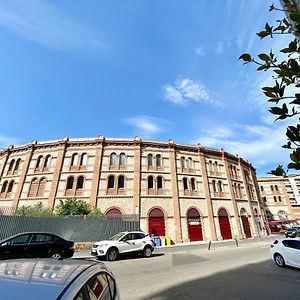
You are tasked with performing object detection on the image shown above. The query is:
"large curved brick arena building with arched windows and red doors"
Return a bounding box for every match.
[0,136,266,242]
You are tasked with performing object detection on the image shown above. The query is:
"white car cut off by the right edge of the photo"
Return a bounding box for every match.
[270,238,300,268]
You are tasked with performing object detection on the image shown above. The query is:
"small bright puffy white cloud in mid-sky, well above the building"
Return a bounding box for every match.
[163,78,217,106]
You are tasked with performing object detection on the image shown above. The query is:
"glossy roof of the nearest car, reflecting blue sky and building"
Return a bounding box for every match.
[0,259,109,300]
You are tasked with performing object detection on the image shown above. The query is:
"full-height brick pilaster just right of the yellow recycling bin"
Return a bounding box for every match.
[169,140,182,243]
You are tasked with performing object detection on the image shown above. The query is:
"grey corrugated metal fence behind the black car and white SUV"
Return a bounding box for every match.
[0,214,140,242]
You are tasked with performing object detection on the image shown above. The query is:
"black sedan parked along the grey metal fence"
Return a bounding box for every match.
[0,232,74,259]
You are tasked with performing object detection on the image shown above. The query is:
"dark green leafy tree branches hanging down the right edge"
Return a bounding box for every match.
[239,0,300,175]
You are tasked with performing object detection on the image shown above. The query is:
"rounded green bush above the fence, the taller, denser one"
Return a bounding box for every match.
[56,198,91,216]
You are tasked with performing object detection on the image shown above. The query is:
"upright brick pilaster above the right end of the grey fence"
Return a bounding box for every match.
[132,136,142,217]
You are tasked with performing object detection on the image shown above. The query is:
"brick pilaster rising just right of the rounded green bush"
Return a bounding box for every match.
[90,135,105,208]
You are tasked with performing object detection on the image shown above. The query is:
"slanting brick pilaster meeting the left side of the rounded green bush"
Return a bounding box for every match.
[48,137,69,209]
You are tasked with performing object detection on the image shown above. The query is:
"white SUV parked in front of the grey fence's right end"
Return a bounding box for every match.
[91,231,154,261]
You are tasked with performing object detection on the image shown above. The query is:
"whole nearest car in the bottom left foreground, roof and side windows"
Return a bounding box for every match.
[0,258,119,300]
